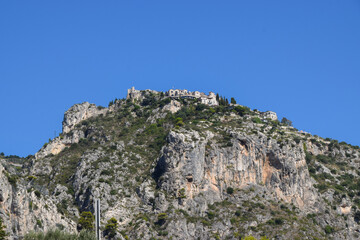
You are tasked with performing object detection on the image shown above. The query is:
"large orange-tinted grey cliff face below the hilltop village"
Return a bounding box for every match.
[159,129,317,208]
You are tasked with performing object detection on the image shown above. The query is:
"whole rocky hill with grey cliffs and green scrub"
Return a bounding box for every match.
[0,90,360,239]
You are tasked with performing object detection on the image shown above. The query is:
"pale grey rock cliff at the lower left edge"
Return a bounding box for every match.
[0,160,76,239]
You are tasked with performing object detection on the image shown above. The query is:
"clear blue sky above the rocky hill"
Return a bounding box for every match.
[0,0,360,156]
